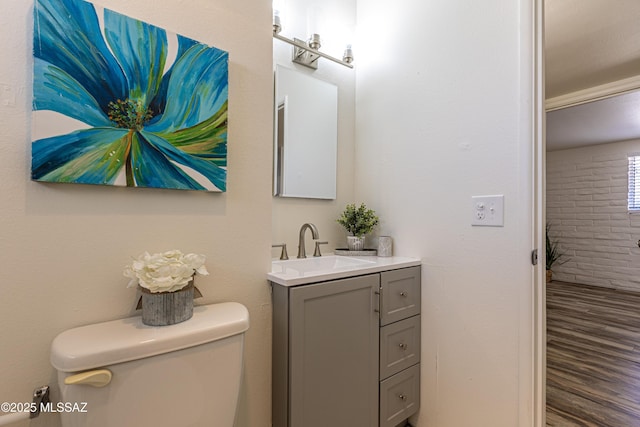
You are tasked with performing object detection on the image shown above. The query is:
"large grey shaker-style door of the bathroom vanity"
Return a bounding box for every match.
[289,274,379,427]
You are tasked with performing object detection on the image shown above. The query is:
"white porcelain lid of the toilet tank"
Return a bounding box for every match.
[51,302,249,372]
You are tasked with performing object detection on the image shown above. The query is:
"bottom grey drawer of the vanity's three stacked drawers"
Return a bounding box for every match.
[380,364,420,427]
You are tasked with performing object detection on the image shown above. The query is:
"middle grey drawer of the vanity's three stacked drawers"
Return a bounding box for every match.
[380,316,420,379]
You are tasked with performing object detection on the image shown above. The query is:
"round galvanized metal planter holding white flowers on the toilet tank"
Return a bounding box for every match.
[140,281,194,326]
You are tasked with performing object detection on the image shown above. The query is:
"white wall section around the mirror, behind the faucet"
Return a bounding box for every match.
[272,0,357,257]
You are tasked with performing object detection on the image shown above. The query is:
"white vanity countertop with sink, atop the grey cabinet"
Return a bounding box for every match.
[267,255,421,286]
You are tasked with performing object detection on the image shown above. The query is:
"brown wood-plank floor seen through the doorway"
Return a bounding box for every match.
[547,282,640,427]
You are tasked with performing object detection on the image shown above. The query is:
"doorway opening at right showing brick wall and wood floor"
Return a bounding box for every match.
[544,0,640,426]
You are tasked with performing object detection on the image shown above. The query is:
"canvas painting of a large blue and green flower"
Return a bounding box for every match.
[31,0,229,191]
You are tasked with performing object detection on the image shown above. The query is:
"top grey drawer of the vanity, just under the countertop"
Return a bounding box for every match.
[380,267,420,326]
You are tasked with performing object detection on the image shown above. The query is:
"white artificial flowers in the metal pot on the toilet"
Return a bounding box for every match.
[124,250,209,293]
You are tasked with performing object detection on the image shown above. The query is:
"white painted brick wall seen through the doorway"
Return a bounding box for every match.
[547,140,640,291]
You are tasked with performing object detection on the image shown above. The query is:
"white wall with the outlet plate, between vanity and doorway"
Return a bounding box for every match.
[356,0,534,427]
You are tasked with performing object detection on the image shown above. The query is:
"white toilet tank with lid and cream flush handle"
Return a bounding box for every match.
[51,302,249,427]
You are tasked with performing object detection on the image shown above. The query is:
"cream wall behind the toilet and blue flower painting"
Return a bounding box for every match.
[0,0,273,427]
